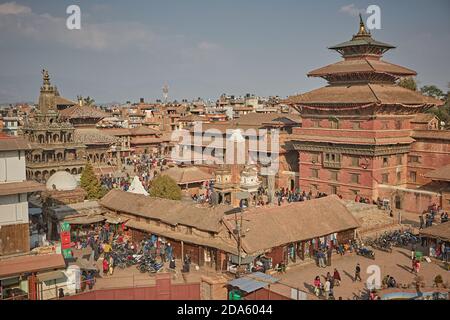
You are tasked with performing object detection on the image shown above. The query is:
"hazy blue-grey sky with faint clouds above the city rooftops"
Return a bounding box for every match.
[0,0,450,102]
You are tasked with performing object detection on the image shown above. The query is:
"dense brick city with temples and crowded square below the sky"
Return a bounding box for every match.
[0,0,450,300]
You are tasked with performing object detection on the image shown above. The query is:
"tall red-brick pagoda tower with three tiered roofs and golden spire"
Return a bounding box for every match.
[285,17,444,209]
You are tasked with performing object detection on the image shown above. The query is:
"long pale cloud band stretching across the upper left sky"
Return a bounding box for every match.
[0,2,218,56]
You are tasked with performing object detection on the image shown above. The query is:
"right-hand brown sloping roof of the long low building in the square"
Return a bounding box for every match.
[224,195,360,255]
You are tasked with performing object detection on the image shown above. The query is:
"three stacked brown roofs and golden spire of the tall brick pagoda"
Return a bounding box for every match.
[285,19,443,114]
